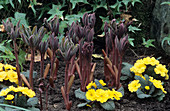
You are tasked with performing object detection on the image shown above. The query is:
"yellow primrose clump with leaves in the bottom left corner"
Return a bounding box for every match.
[0,86,38,110]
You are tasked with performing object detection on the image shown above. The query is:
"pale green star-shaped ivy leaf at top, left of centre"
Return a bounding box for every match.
[47,4,64,21]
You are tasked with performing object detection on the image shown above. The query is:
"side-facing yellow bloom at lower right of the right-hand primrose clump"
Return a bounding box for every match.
[149,77,167,94]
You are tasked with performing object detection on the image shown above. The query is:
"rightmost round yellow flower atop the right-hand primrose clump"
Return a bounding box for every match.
[154,64,168,77]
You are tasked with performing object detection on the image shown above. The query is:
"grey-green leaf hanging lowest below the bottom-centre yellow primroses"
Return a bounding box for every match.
[100,100,115,110]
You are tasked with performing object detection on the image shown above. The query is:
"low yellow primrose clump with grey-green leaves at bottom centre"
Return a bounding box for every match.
[75,79,124,110]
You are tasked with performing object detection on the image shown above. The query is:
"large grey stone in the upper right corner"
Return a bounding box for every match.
[151,0,170,56]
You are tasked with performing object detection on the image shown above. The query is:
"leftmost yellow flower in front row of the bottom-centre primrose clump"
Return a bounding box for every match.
[86,89,96,101]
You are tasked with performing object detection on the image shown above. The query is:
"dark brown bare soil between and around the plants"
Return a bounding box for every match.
[25,45,170,111]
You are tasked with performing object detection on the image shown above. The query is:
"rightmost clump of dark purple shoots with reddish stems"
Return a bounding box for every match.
[102,19,132,89]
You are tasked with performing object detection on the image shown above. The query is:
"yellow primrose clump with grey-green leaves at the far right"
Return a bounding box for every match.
[122,57,169,101]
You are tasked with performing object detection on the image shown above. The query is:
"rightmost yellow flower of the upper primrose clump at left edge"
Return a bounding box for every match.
[6,70,18,83]
